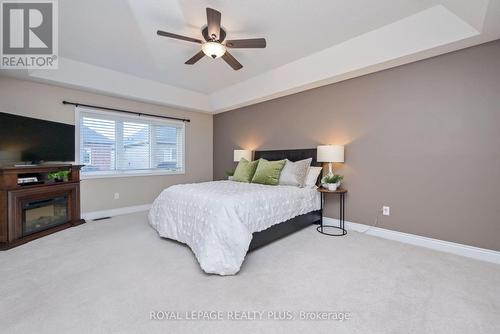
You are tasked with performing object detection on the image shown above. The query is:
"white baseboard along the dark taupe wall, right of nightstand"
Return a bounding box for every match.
[323,217,500,264]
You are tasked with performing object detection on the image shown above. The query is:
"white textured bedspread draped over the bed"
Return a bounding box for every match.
[149,181,320,275]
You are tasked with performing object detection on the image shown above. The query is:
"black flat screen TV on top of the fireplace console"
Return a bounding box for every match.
[0,112,75,166]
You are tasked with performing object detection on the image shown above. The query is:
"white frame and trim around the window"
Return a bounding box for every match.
[75,107,186,180]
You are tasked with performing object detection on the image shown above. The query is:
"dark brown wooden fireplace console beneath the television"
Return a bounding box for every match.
[0,164,85,250]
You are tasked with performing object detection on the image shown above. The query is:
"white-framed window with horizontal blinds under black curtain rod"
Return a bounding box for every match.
[76,107,185,177]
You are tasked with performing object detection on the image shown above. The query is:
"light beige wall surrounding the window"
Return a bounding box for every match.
[0,77,213,212]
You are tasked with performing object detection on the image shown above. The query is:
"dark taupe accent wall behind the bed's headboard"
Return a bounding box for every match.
[214,40,500,250]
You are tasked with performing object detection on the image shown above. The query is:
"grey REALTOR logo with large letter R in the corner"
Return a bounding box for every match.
[0,0,58,69]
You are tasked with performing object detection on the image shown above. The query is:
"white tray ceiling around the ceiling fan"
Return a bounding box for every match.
[2,0,500,112]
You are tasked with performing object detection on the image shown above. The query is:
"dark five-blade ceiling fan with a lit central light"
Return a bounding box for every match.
[157,8,266,71]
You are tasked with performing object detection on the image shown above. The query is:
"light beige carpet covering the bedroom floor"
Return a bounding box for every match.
[0,213,500,333]
